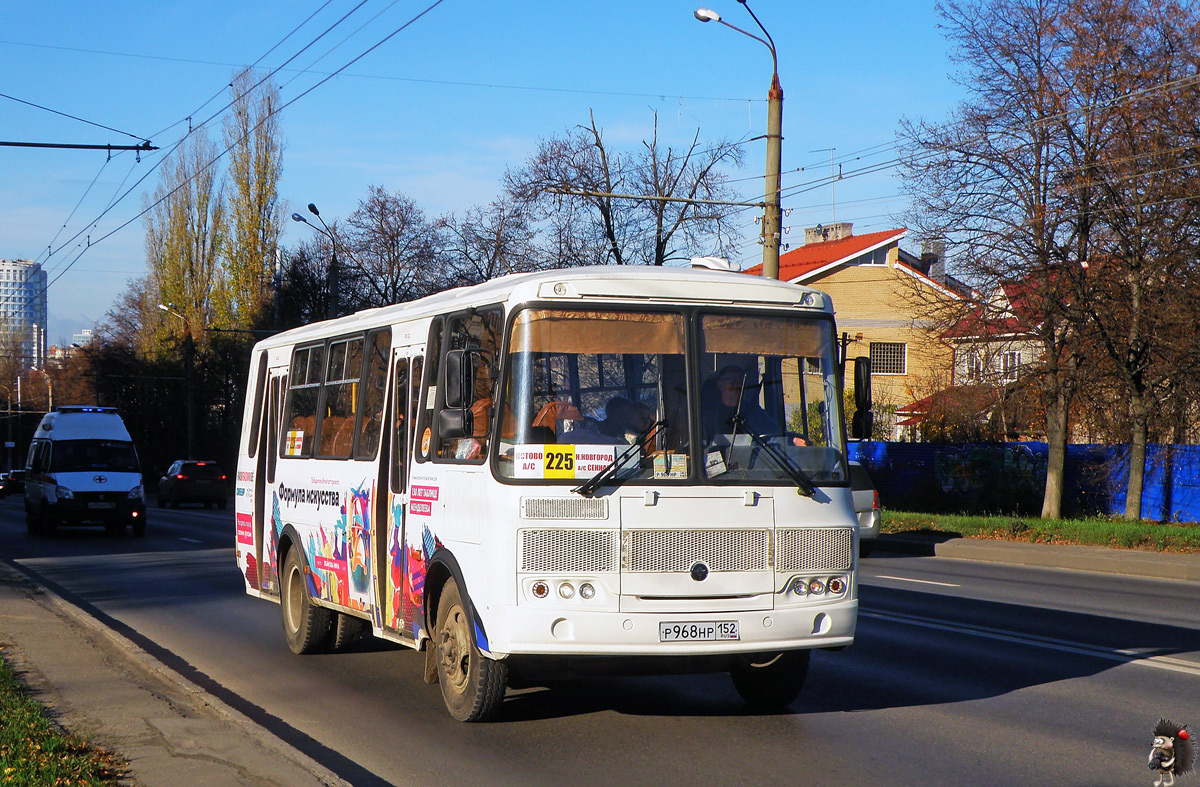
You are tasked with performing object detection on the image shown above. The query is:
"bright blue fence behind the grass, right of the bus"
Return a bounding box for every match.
[850,440,1200,522]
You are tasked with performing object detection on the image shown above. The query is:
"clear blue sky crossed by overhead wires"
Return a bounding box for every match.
[0,0,961,344]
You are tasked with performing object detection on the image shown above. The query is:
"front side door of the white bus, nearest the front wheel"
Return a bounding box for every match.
[376,347,425,641]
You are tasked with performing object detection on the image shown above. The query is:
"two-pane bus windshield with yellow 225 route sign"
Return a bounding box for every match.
[494,308,845,486]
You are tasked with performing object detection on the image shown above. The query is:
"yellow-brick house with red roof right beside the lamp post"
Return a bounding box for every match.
[745,222,970,437]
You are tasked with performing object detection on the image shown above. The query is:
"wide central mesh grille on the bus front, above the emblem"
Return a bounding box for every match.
[622,529,770,572]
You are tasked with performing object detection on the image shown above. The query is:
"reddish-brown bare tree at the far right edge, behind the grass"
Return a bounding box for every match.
[1078,0,1200,518]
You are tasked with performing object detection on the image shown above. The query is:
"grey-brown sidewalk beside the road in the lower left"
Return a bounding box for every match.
[0,564,347,787]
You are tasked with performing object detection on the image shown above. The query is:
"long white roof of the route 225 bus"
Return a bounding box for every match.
[256,265,833,349]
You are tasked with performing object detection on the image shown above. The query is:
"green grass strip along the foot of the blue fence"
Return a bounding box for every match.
[882,510,1200,552]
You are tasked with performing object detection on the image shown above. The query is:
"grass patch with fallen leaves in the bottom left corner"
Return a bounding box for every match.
[0,657,125,787]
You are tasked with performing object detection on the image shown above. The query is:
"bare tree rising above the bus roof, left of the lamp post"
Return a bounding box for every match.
[505,114,744,266]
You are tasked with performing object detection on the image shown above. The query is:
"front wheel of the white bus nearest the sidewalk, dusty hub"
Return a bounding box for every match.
[428,579,509,721]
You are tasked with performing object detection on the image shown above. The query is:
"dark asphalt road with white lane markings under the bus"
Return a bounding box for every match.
[0,498,1200,785]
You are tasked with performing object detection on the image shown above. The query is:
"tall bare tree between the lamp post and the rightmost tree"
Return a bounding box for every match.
[901,0,1090,518]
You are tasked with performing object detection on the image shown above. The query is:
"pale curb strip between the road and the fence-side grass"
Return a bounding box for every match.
[875,534,1200,582]
